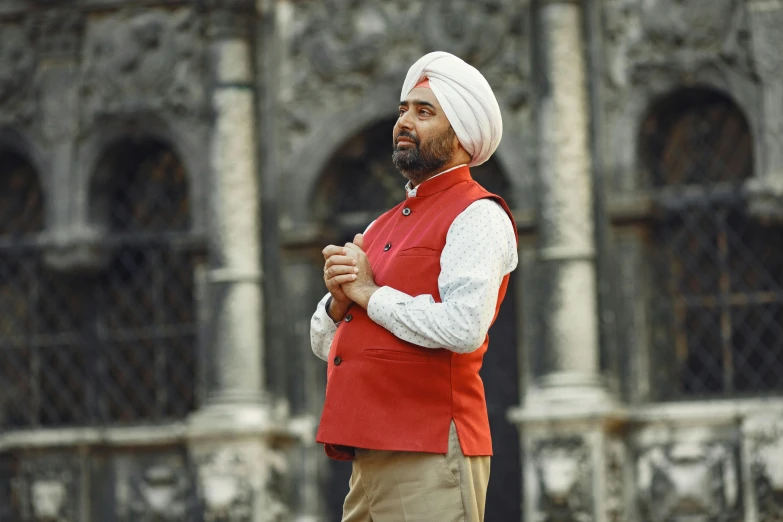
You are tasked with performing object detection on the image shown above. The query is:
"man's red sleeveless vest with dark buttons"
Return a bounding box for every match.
[316,167,516,460]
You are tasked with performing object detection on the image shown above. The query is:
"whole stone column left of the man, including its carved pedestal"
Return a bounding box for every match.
[189,0,286,522]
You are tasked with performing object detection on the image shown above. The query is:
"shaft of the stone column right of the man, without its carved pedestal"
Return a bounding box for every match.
[528,0,603,402]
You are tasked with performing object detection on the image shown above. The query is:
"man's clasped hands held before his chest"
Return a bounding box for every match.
[322,234,379,321]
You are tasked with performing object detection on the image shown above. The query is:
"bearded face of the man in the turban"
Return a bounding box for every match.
[392,87,459,185]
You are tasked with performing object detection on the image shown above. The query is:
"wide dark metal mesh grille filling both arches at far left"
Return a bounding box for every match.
[0,143,198,428]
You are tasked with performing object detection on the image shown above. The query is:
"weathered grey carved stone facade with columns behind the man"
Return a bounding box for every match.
[0,0,783,522]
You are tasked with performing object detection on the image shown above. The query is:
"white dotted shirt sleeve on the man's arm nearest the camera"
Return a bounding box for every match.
[367,199,518,353]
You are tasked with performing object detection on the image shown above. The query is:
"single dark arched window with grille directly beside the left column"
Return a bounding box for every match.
[90,141,196,422]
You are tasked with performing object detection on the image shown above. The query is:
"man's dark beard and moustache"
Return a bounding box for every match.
[392,127,456,185]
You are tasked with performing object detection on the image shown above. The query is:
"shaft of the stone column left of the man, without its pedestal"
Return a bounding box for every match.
[198,0,264,412]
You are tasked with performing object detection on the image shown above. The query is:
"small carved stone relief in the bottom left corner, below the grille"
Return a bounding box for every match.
[14,456,80,522]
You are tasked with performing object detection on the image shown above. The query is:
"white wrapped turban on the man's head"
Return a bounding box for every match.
[400,51,503,167]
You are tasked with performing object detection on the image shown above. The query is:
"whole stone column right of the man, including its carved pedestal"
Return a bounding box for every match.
[509,0,628,522]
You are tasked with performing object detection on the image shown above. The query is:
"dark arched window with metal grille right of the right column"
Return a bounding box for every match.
[640,89,783,398]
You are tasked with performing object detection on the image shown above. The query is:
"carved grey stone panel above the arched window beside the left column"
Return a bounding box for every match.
[82,8,206,121]
